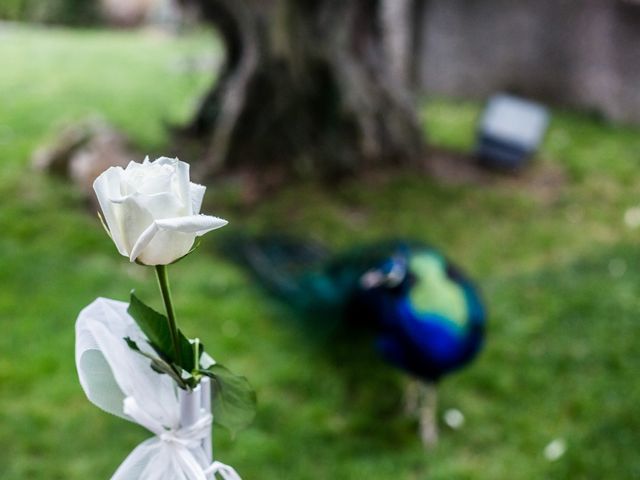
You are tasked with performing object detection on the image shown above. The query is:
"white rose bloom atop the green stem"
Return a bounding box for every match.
[93,157,227,265]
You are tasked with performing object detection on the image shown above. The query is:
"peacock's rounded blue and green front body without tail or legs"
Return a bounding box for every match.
[349,245,486,381]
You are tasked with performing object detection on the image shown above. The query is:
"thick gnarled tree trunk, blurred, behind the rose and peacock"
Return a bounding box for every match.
[182,0,423,183]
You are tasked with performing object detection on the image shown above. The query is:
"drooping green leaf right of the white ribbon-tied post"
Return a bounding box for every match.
[200,363,257,435]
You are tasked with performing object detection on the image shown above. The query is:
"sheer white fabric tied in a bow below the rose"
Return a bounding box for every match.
[76,298,241,480]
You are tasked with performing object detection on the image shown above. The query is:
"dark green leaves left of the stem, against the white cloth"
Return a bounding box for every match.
[127,292,195,372]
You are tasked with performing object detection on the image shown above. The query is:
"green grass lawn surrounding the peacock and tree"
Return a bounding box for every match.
[0,26,640,480]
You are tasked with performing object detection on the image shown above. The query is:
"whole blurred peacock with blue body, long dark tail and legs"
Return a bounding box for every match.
[228,236,487,447]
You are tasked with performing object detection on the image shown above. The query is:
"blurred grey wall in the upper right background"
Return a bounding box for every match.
[421,0,640,123]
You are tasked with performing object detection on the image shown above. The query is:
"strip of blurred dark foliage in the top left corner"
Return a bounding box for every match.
[0,0,102,26]
